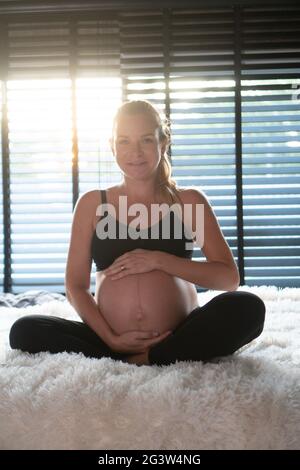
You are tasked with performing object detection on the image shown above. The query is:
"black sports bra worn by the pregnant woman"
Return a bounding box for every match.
[91,190,193,271]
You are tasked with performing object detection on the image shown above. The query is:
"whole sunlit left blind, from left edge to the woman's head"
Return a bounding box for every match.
[2,15,121,293]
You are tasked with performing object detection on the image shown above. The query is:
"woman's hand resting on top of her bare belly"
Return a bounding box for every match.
[102,248,161,280]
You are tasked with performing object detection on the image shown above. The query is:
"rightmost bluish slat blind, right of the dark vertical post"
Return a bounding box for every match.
[241,7,300,287]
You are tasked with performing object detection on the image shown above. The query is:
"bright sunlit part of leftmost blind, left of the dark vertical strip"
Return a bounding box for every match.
[8,80,72,292]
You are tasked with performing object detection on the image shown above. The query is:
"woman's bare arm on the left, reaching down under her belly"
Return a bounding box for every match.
[65,191,113,345]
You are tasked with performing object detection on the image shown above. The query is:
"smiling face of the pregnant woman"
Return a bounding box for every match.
[111,113,165,179]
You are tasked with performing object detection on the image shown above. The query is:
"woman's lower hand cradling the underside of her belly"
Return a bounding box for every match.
[110,330,172,354]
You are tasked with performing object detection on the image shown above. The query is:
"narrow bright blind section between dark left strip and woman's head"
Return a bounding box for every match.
[75,14,122,291]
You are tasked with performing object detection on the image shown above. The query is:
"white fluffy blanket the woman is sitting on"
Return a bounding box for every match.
[0,286,300,450]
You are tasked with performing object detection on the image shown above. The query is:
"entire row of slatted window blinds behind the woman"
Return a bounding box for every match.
[0,4,300,292]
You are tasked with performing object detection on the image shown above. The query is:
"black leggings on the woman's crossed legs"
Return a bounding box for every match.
[9,291,265,365]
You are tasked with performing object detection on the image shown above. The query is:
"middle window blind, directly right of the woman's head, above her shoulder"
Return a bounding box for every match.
[121,10,237,290]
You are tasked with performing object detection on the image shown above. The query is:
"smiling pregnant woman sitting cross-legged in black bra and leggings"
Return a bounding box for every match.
[10,101,265,365]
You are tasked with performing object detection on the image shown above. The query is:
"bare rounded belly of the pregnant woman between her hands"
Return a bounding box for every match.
[95,270,198,334]
